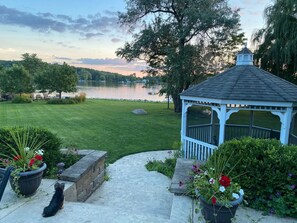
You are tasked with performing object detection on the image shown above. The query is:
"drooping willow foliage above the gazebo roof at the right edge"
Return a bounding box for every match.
[254,0,297,83]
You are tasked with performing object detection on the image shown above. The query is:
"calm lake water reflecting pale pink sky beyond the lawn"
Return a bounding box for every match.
[77,81,167,101]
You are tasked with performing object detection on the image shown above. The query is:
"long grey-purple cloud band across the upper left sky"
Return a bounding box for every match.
[0,5,119,39]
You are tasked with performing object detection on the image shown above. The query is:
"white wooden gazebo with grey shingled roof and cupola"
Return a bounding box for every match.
[180,47,297,160]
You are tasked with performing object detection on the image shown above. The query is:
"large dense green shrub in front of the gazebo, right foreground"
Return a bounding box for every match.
[210,138,297,218]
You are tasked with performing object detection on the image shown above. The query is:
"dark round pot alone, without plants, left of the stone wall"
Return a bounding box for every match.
[10,163,46,197]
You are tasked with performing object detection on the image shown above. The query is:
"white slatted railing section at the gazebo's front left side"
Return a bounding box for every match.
[183,137,217,161]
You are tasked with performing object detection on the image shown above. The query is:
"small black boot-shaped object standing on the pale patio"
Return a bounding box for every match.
[42,183,65,217]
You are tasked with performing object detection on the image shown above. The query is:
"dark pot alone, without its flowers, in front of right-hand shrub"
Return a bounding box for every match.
[200,196,243,223]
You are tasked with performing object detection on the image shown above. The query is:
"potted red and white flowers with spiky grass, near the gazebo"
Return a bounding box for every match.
[192,152,244,223]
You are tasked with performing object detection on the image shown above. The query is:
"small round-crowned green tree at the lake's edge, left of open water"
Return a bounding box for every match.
[36,62,78,99]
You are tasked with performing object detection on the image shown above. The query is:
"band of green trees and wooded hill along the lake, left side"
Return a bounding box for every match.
[0,53,142,98]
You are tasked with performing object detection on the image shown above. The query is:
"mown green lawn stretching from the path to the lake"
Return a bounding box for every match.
[0,99,180,162]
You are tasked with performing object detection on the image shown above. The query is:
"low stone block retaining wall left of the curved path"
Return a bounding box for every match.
[60,150,107,202]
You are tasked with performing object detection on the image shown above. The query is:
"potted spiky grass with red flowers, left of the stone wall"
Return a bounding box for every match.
[1,128,46,196]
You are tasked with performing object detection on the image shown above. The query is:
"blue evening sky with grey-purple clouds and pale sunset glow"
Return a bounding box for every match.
[0,0,272,76]
